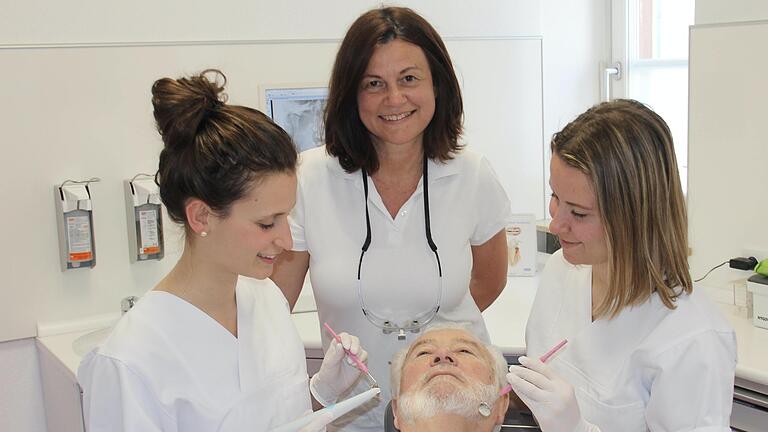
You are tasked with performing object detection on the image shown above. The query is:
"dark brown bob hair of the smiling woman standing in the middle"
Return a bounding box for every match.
[325,7,464,173]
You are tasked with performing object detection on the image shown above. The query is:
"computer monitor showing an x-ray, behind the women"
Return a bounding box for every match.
[263,85,328,152]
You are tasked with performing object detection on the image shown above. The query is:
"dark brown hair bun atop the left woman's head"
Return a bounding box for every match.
[152,69,227,150]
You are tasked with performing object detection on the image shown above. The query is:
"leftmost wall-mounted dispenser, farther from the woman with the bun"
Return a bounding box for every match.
[53,178,100,271]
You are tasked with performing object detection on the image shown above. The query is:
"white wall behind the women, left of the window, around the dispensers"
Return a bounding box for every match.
[0,0,544,341]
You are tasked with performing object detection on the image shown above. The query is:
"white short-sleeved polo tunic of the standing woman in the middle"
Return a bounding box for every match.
[291,147,511,431]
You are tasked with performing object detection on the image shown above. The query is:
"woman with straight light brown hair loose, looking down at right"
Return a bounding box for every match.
[507,100,736,432]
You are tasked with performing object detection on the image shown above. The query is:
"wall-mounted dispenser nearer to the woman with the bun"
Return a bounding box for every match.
[125,174,165,262]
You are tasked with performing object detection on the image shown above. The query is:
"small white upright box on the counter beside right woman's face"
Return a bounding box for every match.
[507,214,536,276]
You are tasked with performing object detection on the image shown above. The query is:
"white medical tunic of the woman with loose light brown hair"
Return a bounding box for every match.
[526,251,736,432]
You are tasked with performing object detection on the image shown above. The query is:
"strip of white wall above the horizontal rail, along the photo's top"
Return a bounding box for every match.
[0,0,541,45]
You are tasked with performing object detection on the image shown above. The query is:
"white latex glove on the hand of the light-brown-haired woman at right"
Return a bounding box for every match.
[507,356,600,432]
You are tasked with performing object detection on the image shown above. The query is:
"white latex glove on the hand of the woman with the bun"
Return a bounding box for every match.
[309,332,368,406]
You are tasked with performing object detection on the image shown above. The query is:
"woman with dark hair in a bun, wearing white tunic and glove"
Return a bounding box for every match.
[78,71,367,432]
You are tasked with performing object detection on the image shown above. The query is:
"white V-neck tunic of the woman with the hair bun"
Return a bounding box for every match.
[78,277,311,432]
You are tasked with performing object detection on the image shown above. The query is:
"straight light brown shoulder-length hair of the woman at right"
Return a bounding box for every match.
[552,100,693,317]
